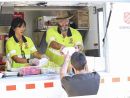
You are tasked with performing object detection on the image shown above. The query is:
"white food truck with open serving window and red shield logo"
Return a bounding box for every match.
[0,0,130,98]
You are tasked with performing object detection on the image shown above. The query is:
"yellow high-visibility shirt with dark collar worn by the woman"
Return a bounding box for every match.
[6,36,37,68]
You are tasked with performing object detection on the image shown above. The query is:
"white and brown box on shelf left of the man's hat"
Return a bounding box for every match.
[37,16,56,30]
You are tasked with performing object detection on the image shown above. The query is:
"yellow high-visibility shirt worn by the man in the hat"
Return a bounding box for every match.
[46,26,83,66]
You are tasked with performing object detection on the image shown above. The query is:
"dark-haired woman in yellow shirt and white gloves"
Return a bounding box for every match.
[6,17,45,68]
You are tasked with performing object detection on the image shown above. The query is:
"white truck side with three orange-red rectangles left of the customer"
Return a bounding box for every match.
[0,74,67,98]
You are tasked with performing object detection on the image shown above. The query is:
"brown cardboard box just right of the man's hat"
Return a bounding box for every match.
[72,10,89,28]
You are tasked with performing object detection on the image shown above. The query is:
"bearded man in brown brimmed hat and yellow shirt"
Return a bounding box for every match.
[46,11,83,66]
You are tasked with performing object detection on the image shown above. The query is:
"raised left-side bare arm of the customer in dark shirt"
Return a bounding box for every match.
[60,54,70,79]
